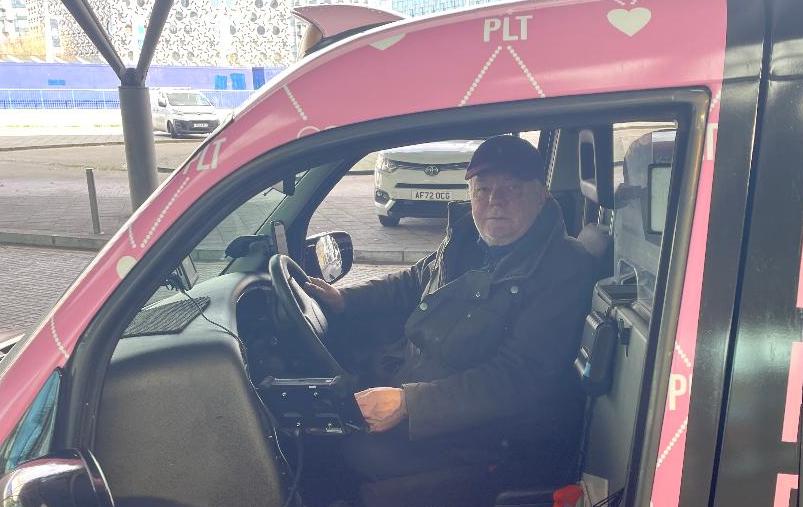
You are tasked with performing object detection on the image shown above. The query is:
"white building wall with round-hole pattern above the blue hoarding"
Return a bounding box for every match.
[7,0,472,67]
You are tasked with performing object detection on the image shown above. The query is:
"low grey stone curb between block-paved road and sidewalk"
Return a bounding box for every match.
[0,229,432,264]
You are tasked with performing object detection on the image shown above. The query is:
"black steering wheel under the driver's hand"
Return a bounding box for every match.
[268,254,346,376]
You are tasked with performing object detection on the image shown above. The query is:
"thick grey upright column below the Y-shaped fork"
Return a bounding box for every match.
[119,82,159,211]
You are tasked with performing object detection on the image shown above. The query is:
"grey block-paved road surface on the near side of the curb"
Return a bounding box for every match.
[0,245,403,342]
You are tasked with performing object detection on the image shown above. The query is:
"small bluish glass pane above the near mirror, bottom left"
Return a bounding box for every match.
[0,371,61,474]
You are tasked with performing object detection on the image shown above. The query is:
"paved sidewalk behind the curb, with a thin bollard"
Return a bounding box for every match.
[0,169,445,264]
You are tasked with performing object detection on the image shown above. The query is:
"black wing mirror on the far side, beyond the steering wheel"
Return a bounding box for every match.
[304,232,354,283]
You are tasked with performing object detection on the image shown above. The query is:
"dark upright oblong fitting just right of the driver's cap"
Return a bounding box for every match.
[577,125,613,209]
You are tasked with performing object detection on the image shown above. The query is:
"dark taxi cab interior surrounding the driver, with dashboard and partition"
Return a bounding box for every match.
[56,94,700,507]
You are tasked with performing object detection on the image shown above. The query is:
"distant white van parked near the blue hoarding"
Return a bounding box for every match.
[151,88,220,138]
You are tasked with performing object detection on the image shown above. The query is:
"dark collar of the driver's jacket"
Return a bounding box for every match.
[444,197,566,283]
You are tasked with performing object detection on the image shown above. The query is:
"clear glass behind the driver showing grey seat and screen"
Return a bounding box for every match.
[613,122,675,312]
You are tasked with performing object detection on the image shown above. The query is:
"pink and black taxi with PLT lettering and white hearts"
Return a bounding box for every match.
[0,0,803,507]
